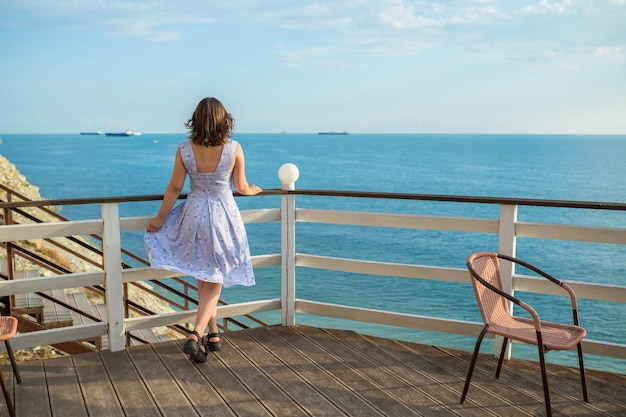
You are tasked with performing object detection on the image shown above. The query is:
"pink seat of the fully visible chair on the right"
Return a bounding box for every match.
[487,316,587,350]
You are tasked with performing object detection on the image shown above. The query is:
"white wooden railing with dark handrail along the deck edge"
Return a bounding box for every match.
[0,185,626,368]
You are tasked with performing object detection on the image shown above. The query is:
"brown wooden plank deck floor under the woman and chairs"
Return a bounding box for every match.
[0,326,626,417]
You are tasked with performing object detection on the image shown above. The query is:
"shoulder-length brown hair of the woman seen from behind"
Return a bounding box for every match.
[185,97,235,146]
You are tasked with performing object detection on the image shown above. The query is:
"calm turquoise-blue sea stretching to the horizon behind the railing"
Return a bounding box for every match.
[0,132,626,374]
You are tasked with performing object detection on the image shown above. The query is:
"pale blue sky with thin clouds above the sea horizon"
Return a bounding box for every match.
[0,0,626,134]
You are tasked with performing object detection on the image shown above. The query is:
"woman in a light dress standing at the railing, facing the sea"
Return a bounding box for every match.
[144,97,263,362]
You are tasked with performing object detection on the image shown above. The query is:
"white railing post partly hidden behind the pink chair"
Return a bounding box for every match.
[494,205,518,360]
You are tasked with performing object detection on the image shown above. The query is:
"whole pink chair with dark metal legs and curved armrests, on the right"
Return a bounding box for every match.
[461,252,589,417]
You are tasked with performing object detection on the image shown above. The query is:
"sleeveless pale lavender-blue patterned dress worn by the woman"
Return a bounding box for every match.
[144,140,255,288]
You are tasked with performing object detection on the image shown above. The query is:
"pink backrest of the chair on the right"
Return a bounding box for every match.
[467,252,511,325]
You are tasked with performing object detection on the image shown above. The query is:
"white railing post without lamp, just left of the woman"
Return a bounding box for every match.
[102,203,126,352]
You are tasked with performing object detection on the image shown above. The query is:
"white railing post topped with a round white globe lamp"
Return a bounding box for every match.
[278,163,300,326]
